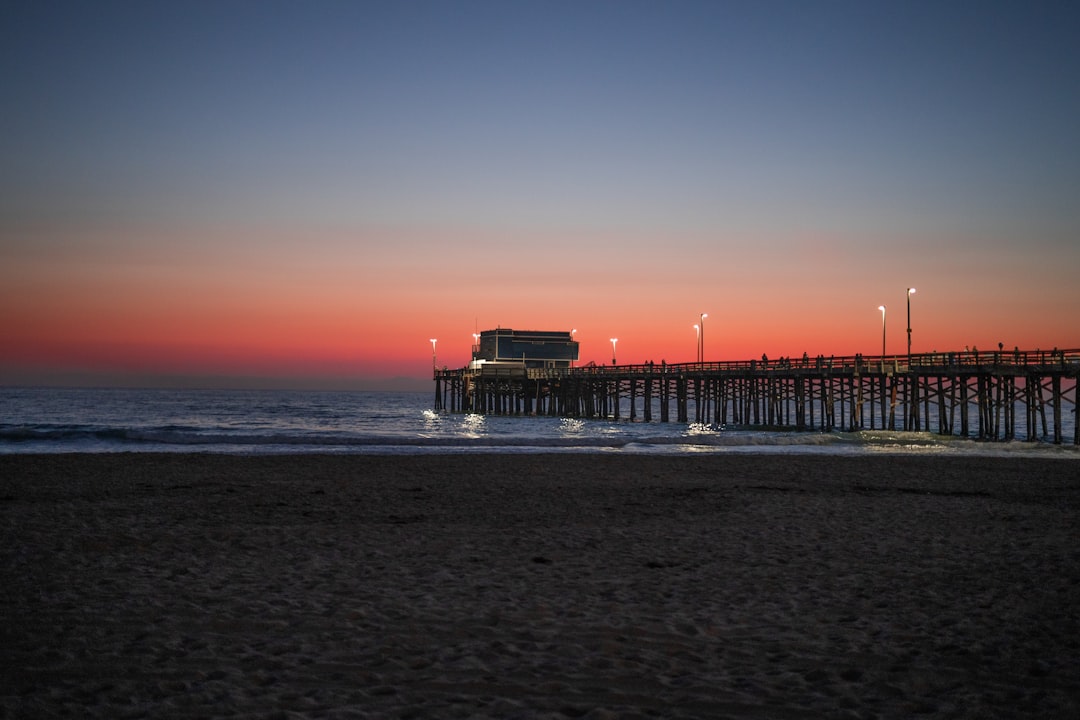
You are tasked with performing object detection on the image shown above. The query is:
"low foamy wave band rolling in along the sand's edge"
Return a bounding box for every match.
[0,421,1080,458]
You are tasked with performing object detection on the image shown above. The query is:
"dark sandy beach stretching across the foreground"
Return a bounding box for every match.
[0,454,1080,718]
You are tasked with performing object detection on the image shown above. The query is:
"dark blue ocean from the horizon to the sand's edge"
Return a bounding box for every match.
[0,388,1080,459]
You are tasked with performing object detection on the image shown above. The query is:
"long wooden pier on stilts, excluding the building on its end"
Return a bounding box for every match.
[434,350,1080,445]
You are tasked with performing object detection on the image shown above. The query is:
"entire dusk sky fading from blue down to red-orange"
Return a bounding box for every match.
[0,0,1080,389]
